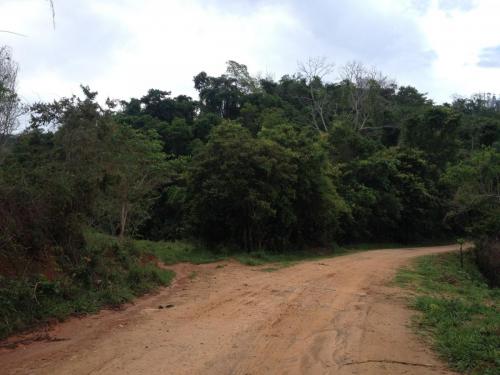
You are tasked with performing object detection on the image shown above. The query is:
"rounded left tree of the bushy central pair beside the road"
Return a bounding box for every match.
[188,122,297,251]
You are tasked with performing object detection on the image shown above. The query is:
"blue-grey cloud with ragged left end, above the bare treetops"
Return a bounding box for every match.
[191,0,438,86]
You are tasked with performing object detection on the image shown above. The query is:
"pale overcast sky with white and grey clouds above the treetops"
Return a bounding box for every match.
[0,0,500,102]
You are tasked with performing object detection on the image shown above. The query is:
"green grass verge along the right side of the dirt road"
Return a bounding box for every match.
[396,252,500,375]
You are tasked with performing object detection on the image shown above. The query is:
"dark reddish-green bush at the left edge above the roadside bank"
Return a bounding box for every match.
[0,131,86,268]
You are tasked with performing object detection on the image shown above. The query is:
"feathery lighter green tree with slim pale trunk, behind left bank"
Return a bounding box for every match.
[32,87,165,237]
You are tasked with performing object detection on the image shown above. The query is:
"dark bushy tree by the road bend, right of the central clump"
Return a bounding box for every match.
[341,148,443,242]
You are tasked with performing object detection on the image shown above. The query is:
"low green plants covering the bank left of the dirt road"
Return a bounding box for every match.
[0,232,174,338]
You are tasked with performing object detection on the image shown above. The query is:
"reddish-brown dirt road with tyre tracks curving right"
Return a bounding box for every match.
[0,246,460,375]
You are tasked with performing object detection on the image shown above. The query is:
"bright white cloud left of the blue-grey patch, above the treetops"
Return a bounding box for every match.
[88,0,299,100]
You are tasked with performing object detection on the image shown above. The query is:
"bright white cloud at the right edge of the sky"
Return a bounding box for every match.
[420,0,500,100]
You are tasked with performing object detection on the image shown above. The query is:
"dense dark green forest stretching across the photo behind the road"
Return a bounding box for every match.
[0,47,500,336]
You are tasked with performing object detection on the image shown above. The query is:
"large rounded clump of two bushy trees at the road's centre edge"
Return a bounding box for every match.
[189,123,346,250]
